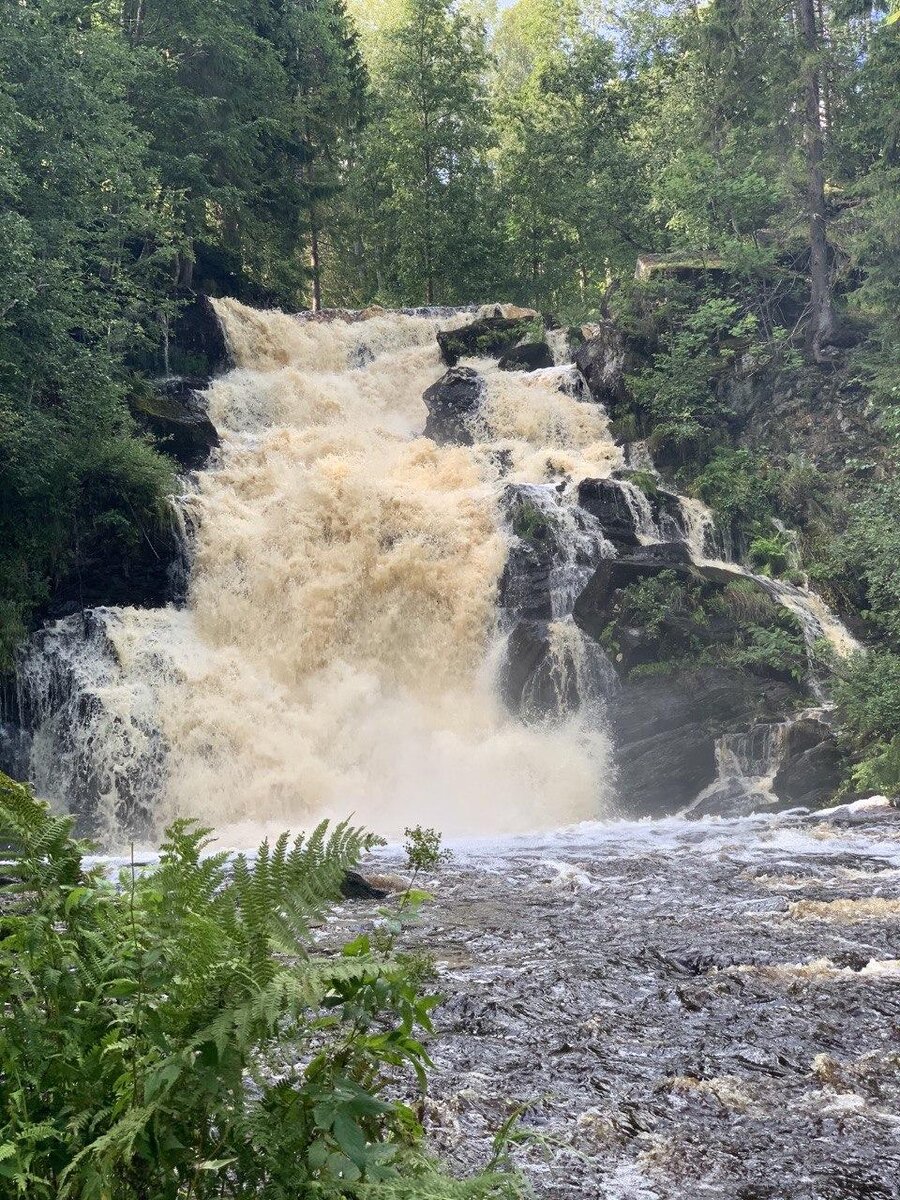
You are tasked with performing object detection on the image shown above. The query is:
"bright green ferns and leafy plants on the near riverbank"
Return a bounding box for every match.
[0,775,517,1200]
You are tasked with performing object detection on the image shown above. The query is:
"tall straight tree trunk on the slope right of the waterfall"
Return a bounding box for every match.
[797,0,834,361]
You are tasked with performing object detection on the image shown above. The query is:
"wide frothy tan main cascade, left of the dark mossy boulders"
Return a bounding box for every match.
[19,300,620,844]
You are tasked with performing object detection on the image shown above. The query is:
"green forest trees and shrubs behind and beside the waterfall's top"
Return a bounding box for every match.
[0,0,900,737]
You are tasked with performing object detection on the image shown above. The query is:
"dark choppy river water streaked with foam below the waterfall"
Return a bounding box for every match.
[334,808,900,1200]
